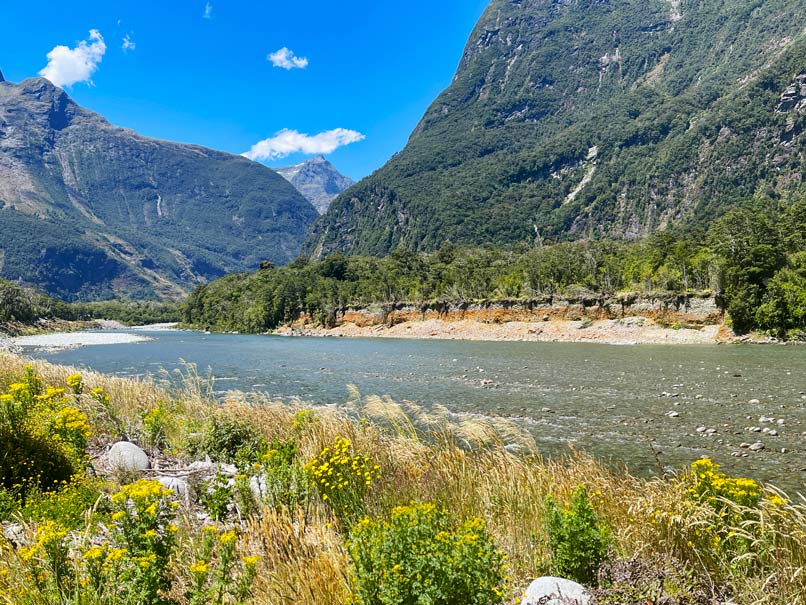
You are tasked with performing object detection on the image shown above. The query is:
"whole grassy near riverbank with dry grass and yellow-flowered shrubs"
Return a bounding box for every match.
[0,355,806,605]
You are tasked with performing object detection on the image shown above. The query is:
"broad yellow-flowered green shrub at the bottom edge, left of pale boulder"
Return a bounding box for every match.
[347,504,506,605]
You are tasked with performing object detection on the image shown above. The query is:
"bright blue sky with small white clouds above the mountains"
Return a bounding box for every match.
[0,0,487,179]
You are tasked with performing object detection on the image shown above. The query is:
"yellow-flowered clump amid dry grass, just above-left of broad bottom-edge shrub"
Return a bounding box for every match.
[305,437,380,524]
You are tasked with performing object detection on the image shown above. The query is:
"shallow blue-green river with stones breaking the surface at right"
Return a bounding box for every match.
[14,331,806,492]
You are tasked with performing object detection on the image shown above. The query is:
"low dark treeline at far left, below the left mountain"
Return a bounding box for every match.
[0,280,180,325]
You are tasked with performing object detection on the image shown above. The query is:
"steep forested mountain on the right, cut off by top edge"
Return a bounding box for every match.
[304,0,806,257]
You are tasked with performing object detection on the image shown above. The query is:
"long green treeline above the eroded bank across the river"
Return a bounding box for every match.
[182,200,806,336]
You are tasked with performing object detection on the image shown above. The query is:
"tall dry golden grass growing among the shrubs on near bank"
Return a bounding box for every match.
[0,355,806,605]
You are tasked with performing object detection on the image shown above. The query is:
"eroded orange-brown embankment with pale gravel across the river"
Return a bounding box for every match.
[277,293,735,344]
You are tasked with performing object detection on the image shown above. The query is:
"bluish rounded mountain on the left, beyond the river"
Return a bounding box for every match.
[0,78,317,300]
